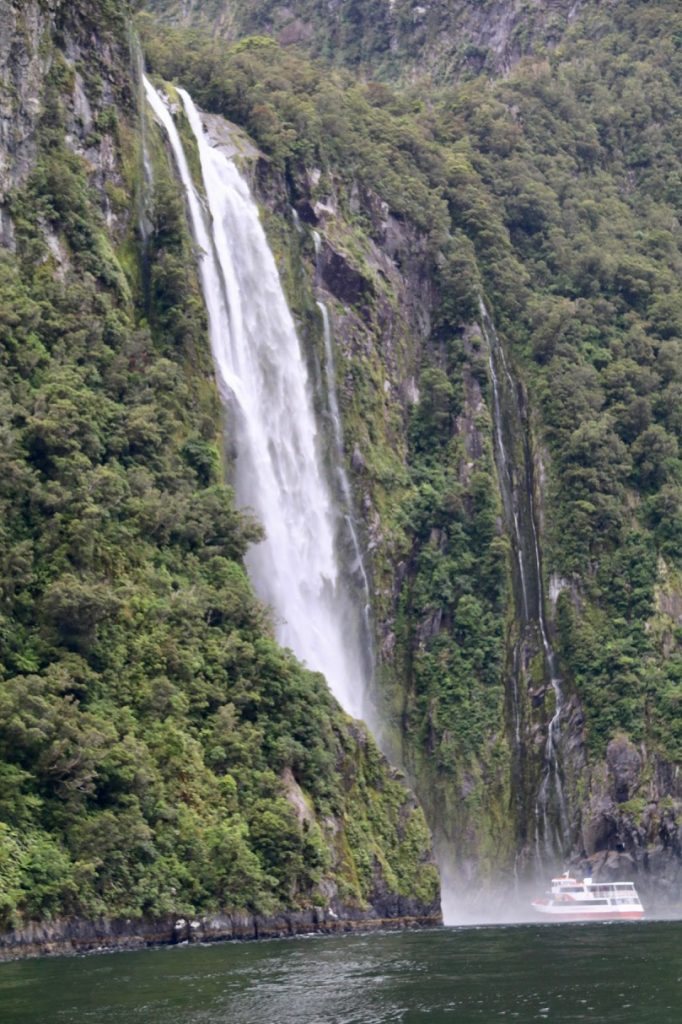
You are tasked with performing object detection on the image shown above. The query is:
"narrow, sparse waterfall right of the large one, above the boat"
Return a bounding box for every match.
[479,299,568,863]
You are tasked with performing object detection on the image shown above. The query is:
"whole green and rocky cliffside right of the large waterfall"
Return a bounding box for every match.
[138,3,680,913]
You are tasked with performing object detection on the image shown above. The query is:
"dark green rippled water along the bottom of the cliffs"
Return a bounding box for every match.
[0,922,682,1024]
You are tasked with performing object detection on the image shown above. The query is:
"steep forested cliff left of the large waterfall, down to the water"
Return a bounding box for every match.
[0,0,439,951]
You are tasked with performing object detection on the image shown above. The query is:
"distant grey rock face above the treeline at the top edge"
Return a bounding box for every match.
[142,0,594,82]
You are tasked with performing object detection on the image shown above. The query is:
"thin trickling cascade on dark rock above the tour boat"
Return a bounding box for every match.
[479,299,568,861]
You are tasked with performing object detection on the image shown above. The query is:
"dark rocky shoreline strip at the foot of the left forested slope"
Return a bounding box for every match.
[0,898,442,962]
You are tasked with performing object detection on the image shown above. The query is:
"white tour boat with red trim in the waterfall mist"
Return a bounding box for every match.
[532,871,644,921]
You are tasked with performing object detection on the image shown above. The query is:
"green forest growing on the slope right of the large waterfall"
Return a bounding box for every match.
[139,0,682,864]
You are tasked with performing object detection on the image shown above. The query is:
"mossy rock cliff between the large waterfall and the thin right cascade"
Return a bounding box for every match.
[257,159,515,878]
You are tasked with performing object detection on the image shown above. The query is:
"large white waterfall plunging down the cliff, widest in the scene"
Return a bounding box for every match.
[145,80,365,716]
